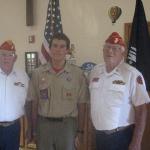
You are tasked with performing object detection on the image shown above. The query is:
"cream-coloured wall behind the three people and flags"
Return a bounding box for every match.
[0,0,150,69]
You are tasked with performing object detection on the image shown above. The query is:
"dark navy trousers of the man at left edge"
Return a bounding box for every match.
[0,120,20,150]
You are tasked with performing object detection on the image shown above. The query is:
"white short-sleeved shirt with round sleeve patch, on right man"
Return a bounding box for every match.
[89,62,150,130]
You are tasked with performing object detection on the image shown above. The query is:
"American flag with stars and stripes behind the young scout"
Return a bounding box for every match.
[39,0,63,64]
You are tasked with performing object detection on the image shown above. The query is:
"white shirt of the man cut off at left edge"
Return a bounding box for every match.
[0,69,28,122]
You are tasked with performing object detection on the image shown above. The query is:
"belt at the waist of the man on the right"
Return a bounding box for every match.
[100,124,134,134]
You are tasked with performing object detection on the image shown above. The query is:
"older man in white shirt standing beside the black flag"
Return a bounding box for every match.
[89,32,150,150]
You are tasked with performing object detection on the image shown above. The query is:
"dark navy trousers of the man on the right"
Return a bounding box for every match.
[96,126,134,150]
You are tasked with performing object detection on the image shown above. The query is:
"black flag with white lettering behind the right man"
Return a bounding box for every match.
[127,0,150,91]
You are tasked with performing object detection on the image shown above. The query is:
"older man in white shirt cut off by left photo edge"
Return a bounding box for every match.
[0,41,28,150]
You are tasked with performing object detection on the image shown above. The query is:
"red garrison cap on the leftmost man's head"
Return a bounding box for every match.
[0,40,16,52]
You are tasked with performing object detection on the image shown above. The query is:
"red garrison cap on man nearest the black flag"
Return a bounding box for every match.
[105,32,125,47]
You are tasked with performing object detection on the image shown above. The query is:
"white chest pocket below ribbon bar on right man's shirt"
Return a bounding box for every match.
[107,84,126,106]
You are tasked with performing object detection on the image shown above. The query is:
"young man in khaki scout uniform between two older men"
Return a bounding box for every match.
[28,34,88,150]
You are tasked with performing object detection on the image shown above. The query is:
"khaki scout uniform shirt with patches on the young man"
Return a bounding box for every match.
[28,63,88,117]
